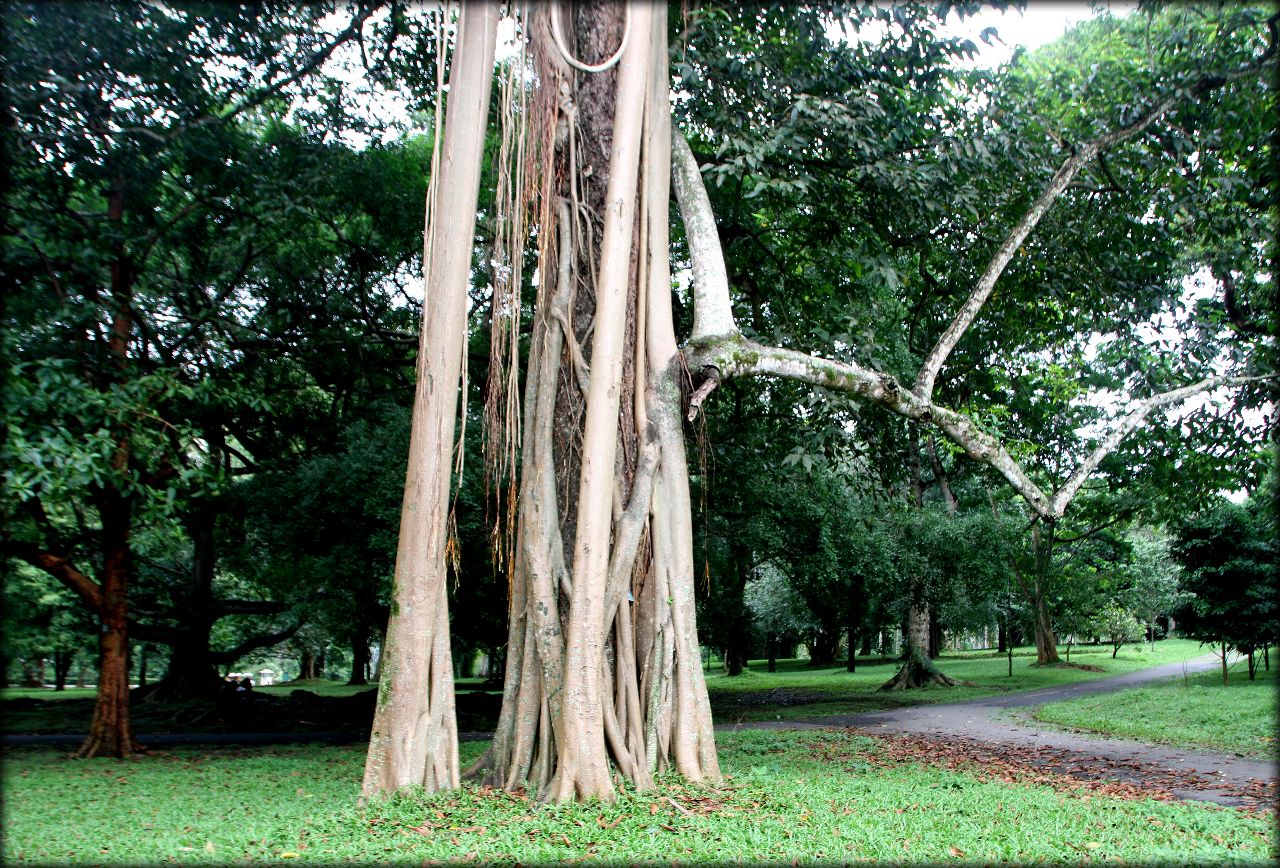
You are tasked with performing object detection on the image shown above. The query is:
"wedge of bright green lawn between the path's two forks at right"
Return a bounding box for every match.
[1034,666,1277,757]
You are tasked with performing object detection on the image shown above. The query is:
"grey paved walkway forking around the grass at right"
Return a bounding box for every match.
[716,655,1280,804]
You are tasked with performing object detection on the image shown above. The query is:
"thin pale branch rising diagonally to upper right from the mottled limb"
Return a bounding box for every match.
[911,97,1176,401]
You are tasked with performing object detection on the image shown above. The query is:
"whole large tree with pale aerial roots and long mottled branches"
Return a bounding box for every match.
[364,3,1261,801]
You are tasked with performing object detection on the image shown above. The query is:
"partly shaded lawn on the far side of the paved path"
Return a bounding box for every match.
[707,639,1208,723]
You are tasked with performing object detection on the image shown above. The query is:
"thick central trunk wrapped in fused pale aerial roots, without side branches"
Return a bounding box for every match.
[470,3,719,801]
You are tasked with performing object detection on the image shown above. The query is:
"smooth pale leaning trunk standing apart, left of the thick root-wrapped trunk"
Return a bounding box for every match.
[361,3,498,799]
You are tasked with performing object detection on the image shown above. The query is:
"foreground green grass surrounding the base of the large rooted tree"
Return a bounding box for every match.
[0,731,1277,864]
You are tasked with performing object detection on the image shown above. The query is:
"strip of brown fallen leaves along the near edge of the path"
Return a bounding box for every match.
[814,731,1280,816]
